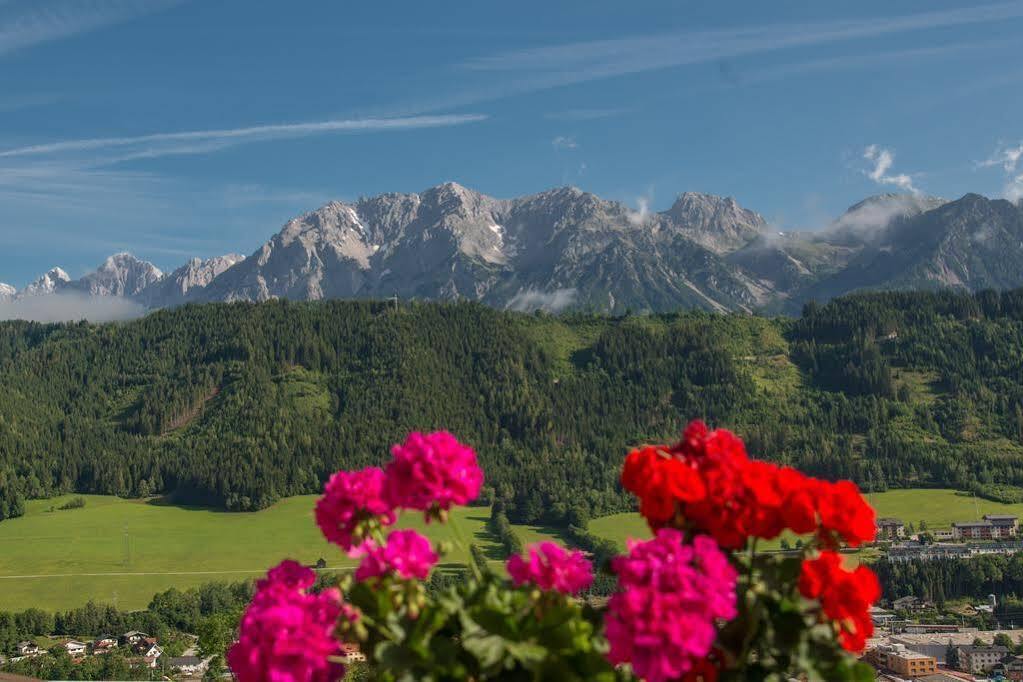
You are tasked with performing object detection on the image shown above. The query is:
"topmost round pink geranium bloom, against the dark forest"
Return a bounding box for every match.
[387,431,483,511]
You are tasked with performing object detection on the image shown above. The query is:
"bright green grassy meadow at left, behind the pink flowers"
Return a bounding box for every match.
[0,496,511,610]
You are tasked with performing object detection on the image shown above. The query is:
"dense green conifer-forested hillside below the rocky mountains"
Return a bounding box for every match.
[6,291,1023,524]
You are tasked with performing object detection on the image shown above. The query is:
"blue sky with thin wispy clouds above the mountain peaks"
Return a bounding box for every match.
[0,0,1023,286]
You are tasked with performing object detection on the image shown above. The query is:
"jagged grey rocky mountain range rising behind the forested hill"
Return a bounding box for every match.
[0,183,1023,313]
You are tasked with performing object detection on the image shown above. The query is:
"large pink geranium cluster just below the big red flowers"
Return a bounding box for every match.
[606,528,737,682]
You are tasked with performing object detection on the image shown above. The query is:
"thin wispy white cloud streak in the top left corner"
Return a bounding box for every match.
[0,0,181,54]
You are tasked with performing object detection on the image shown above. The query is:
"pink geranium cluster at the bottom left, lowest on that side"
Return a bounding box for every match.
[227,561,345,682]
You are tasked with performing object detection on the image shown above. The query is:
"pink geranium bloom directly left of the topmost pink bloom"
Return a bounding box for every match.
[316,466,395,552]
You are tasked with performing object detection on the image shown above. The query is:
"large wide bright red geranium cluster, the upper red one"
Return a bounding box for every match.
[622,421,876,549]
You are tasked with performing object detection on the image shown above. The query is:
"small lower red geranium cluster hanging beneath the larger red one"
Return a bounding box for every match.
[799,550,881,651]
